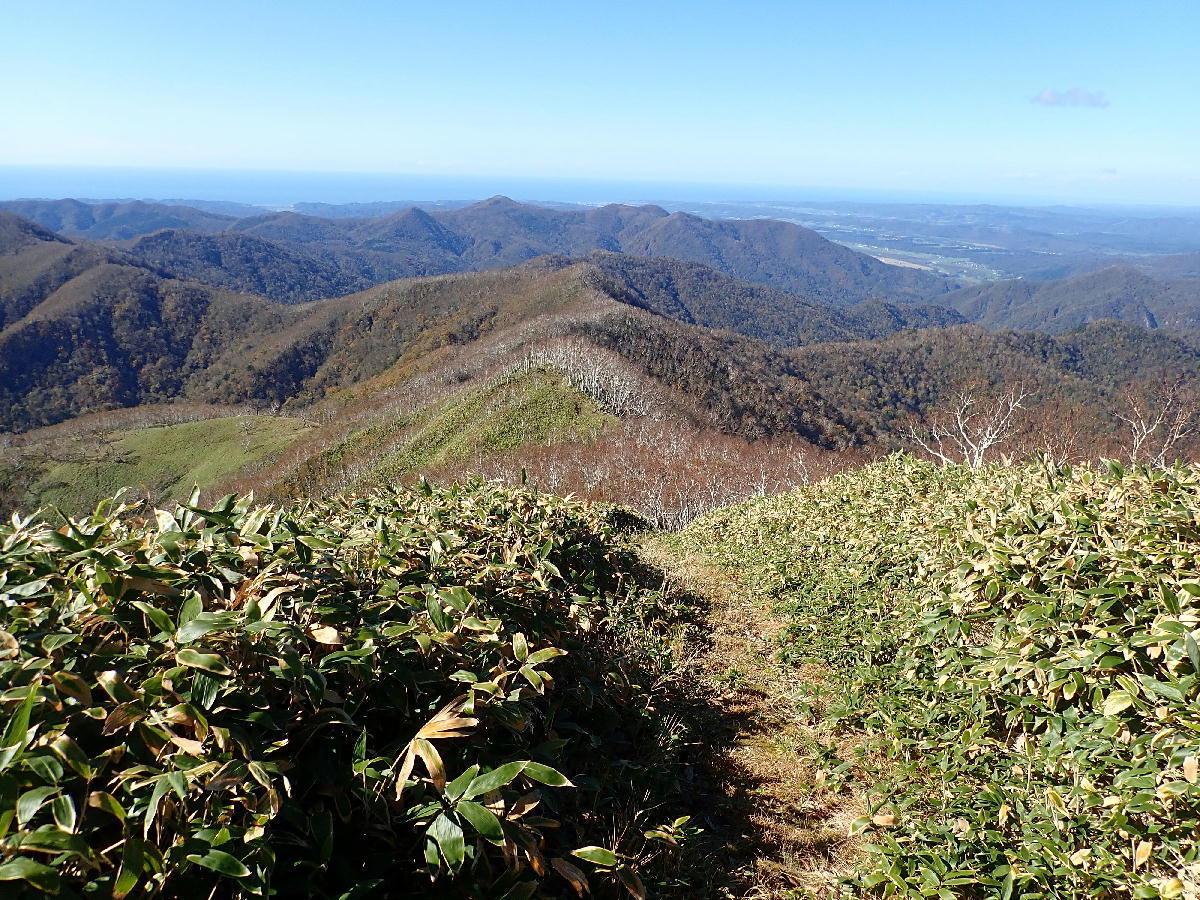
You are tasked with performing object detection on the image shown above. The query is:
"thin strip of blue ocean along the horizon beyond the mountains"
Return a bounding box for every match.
[0,166,998,209]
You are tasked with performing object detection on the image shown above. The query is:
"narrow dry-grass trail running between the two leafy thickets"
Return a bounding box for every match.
[641,538,866,900]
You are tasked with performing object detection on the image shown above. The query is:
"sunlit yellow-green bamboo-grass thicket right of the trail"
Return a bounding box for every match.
[691,457,1200,898]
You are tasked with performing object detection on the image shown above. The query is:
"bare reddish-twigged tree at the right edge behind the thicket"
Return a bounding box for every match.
[1117,376,1200,468]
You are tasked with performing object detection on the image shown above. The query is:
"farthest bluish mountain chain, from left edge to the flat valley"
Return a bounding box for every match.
[0,197,956,306]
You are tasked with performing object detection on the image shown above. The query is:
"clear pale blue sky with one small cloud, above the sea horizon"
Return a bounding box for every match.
[0,0,1200,204]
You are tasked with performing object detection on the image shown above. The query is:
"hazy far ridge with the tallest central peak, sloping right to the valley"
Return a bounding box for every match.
[233,197,953,305]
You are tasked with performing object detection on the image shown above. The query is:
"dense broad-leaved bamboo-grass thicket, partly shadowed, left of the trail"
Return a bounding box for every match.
[0,484,670,898]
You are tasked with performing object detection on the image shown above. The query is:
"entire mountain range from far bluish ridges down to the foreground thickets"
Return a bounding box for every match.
[0,198,1200,518]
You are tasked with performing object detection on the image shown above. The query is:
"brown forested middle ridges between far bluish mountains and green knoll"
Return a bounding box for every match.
[0,205,1196,446]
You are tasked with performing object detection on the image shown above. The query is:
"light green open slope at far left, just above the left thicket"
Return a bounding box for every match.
[0,415,312,514]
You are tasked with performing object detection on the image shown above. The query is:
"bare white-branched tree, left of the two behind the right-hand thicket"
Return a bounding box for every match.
[907,388,1030,469]
